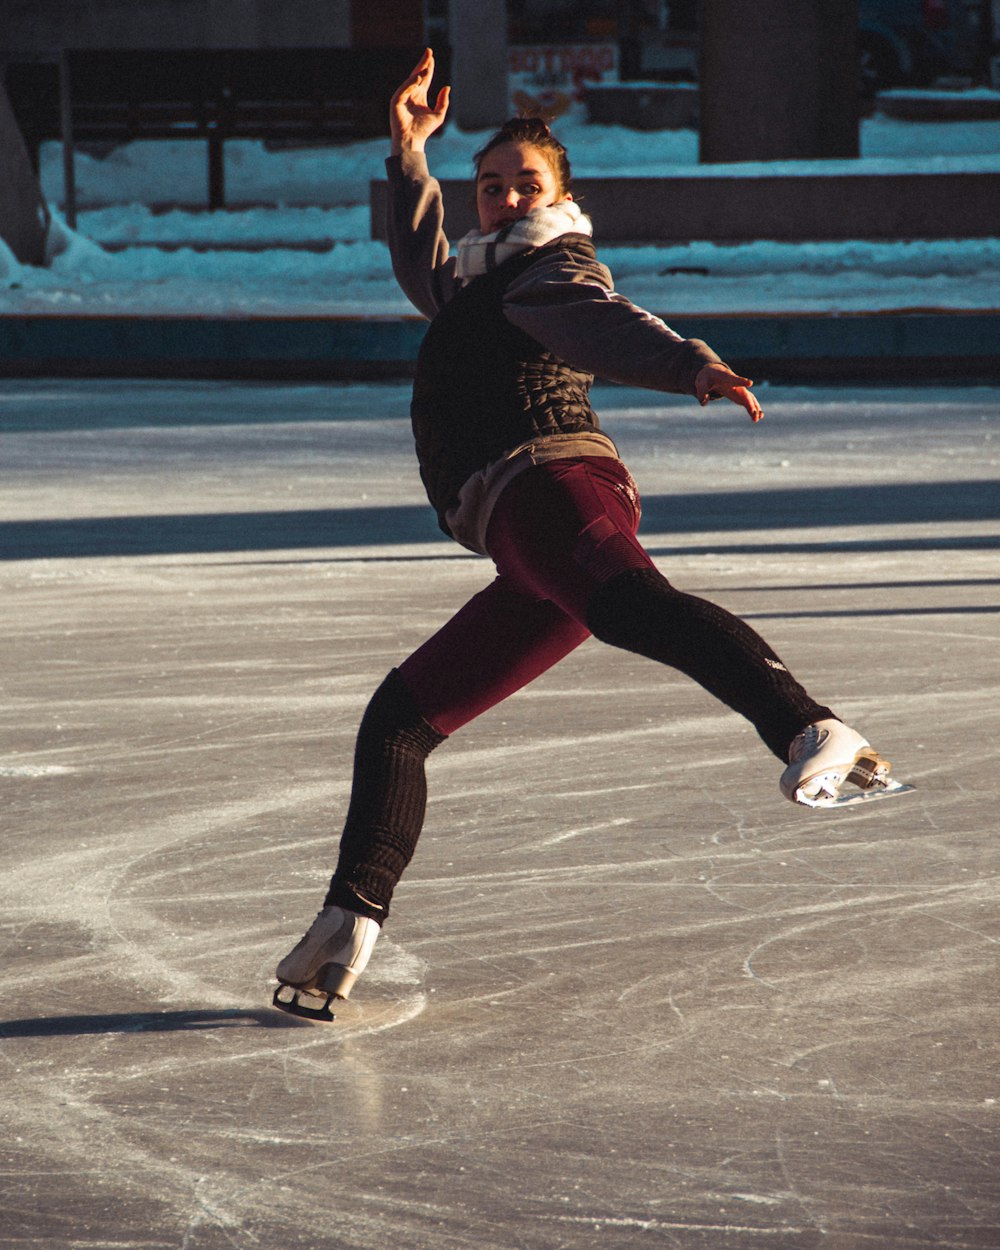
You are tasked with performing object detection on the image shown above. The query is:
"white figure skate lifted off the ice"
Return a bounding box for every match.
[781,720,914,808]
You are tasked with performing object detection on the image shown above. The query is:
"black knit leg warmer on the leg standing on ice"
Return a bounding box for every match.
[325,669,446,923]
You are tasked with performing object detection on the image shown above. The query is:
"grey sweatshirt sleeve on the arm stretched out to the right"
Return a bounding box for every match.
[504,253,719,395]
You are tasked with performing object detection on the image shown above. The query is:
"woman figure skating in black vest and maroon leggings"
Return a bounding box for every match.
[274,49,896,1019]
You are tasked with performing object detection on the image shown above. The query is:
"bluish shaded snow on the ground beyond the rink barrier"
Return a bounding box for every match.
[0,116,1000,316]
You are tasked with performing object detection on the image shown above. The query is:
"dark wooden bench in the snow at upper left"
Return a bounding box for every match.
[6,48,448,226]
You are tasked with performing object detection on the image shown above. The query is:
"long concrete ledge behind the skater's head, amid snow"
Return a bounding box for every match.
[370,173,1000,244]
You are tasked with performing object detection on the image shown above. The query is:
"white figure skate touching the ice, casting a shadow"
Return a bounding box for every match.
[271,906,379,1020]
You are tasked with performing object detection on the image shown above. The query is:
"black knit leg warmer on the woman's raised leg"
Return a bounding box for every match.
[586,569,834,764]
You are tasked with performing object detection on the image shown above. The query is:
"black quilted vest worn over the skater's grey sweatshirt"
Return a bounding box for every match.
[410,235,599,534]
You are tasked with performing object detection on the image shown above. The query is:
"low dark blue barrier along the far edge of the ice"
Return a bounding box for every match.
[0,311,1000,382]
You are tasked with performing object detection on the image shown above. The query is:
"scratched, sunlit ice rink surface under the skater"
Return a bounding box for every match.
[0,381,1000,1250]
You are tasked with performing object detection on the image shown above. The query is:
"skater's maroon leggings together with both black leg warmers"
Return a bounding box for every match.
[326,456,834,920]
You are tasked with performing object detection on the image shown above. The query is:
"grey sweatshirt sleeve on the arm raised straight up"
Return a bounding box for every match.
[385,153,458,318]
